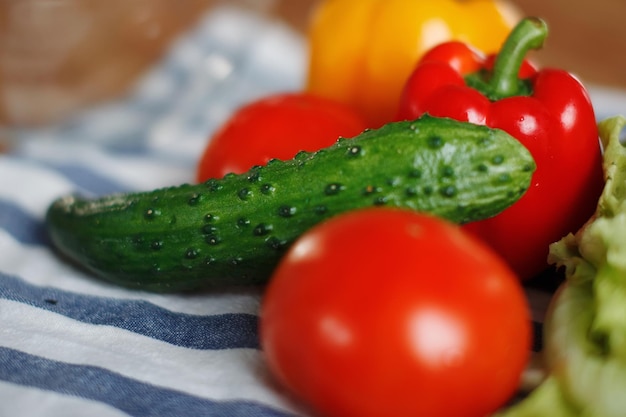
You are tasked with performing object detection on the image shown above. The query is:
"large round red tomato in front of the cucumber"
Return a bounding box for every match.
[260,208,531,417]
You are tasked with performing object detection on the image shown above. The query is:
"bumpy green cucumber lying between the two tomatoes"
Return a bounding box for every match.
[46,115,535,292]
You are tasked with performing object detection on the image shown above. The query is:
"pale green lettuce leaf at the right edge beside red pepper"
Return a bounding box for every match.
[497,116,626,417]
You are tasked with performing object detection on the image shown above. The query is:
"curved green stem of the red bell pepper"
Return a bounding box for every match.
[489,17,548,98]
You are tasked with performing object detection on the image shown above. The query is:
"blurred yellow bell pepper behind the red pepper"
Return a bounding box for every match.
[307,0,518,127]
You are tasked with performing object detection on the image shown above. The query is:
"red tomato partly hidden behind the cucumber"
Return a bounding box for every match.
[196,93,367,181]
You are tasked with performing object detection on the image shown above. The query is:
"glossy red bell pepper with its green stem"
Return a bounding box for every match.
[399,18,603,279]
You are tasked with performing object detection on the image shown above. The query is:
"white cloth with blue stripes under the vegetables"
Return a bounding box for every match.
[0,8,620,417]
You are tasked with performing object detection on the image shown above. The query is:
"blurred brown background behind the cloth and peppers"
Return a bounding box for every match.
[0,0,626,136]
